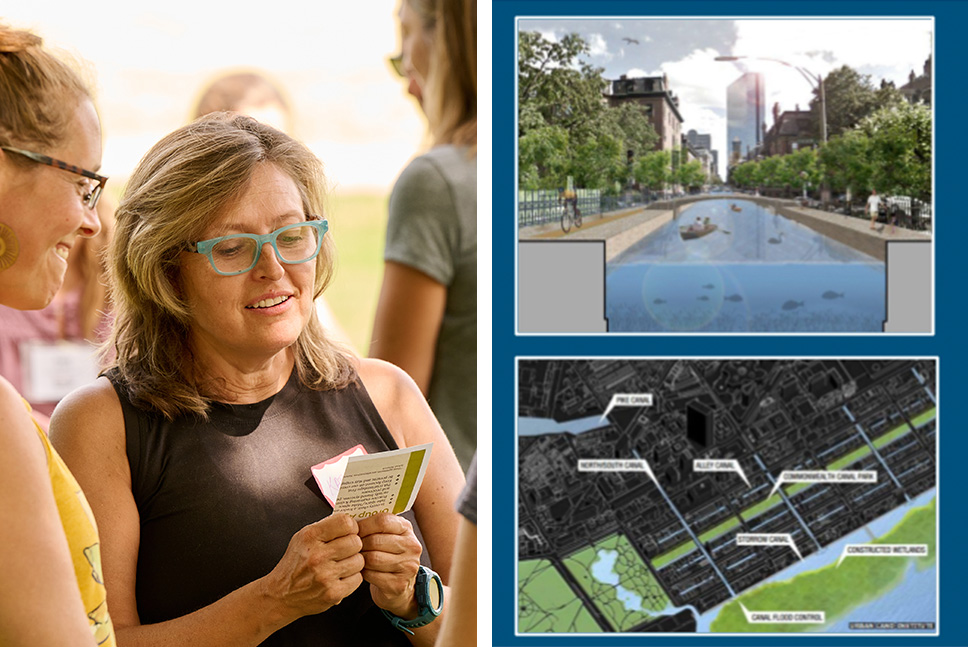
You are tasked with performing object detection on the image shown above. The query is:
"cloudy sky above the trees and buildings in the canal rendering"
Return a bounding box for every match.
[518,17,933,166]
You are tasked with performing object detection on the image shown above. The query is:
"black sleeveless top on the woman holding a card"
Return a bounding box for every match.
[107,371,430,647]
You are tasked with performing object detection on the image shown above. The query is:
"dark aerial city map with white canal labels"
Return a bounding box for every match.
[517,358,938,635]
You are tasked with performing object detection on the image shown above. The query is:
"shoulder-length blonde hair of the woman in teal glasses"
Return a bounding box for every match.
[104,112,355,419]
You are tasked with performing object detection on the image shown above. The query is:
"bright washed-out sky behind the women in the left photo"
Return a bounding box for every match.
[0,0,425,191]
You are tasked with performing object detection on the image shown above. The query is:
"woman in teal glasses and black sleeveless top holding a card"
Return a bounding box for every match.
[51,113,463,646]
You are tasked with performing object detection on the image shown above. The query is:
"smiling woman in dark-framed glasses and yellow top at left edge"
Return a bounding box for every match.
[0,24,115,647]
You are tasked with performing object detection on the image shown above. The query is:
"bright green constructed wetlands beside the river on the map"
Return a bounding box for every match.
[710,499,937,633]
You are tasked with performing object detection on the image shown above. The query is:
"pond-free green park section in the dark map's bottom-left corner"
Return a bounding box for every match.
[518,559,602,633]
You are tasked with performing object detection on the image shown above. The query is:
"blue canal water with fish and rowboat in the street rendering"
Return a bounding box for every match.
[605,199,886,333]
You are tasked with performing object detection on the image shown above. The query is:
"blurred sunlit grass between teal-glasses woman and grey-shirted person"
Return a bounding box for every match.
[325,193,389,356]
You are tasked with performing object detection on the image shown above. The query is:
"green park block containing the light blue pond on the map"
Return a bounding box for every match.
[564,535,669,631]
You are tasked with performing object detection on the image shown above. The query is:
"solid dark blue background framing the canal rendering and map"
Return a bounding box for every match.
[496,0,968,647]
